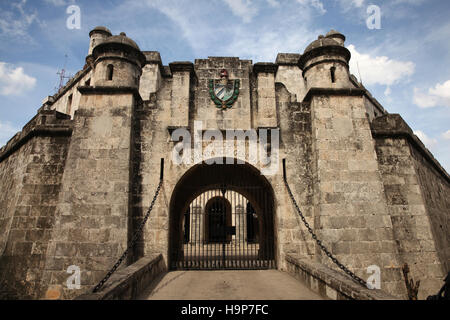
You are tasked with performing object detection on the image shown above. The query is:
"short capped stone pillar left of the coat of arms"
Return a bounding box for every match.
[169,62,194,127]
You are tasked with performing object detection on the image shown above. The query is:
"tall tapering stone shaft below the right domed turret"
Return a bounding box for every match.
[305,89,405,296]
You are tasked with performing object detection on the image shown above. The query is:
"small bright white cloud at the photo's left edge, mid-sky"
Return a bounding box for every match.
[0,62,36,96]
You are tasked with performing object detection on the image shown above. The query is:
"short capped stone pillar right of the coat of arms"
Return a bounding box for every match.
[253,63,278,128]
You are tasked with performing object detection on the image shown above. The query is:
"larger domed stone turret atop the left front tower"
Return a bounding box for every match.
[92,33,145,89]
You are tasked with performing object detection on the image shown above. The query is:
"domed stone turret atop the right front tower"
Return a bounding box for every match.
[299,30,351,89]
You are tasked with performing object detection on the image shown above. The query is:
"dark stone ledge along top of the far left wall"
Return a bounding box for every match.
[0,110,72,163]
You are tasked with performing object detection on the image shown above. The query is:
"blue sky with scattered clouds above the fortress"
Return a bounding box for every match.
[0,0,450,172]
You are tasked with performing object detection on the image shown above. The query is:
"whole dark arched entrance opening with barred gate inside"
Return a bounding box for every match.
[169,159,276,269]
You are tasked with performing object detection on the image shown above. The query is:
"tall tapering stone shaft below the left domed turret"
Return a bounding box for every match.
[40,87,139,299]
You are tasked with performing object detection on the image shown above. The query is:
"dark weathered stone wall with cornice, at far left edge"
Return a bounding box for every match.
[0,111,71,299]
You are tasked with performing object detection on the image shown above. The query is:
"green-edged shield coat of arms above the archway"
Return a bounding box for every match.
[209,69,240,109]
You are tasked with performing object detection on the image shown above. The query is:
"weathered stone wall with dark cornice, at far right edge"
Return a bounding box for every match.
[372,115,449,299]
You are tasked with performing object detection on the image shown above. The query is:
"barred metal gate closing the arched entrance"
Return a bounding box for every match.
[174,186,276,269]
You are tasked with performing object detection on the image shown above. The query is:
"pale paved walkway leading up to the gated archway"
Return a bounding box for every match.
[140,270,323,300]
